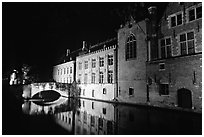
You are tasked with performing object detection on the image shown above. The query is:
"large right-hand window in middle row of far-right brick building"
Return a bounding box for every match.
[179,31,195,55]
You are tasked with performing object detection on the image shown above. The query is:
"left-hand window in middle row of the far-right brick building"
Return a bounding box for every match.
[160,38,172,58]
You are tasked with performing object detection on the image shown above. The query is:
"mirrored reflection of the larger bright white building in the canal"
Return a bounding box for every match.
[75,100,115,135]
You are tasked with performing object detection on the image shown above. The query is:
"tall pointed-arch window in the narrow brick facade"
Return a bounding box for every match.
[126,34,137,60]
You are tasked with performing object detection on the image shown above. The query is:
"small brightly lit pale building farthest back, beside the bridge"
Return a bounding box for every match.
[53,61,75,84]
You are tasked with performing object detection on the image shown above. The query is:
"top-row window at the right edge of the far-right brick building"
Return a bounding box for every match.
[188,6,202,22]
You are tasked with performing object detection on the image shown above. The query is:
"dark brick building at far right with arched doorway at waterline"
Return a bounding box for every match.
[147,2,202,111]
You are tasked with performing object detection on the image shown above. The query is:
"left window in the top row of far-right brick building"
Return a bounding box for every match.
[170,12,183,27]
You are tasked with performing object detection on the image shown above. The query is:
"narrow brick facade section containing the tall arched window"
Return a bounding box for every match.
[117,19,147,103]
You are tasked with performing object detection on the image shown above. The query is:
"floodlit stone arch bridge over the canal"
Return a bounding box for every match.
[23,82,70,98]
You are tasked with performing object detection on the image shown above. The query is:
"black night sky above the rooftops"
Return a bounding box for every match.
[2,2,166,79]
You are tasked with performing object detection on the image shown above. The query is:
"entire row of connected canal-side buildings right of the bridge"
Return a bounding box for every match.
[53,2,202,112]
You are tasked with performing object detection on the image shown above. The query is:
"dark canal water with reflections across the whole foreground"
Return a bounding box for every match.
[2,84,202,135]
